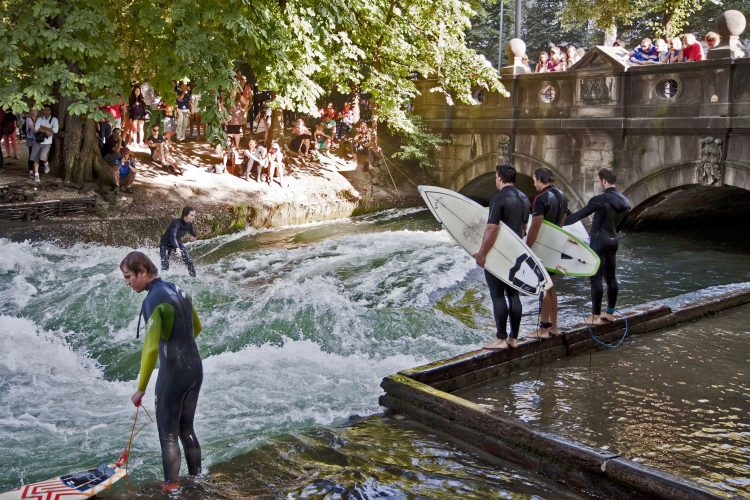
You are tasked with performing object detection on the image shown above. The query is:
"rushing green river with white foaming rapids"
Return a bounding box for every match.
[0,209,750,498]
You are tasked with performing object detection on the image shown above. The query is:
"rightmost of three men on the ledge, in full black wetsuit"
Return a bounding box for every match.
[565,168,630,325]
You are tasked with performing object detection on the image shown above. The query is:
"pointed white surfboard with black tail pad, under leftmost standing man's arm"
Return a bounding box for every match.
[419,186,552,295]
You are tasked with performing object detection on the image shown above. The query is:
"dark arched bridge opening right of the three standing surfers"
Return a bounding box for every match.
[625,184,750,230]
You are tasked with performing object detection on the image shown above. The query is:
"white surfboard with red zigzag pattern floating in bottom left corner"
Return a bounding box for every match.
[0,464,125,500]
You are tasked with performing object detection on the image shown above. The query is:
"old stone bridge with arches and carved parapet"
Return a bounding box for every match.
[415,33,750,226]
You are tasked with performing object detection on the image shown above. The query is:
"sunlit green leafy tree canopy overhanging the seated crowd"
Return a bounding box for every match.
[0,0,502,176]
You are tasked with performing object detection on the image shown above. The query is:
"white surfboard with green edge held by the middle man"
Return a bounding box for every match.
[529,218,599,276]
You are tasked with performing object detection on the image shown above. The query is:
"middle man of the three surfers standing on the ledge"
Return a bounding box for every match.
[526,167,568,339]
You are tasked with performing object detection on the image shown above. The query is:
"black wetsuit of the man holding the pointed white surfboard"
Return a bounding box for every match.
[484,186,530,339]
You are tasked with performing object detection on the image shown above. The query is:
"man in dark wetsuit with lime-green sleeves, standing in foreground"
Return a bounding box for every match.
[120,252,203,490]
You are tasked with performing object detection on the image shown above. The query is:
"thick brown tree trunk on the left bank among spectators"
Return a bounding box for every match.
[51,97,114,184]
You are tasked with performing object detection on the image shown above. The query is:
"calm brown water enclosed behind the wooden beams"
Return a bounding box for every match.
[461,306,750,496]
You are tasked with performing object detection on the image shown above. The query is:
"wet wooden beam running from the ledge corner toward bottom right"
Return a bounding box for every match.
[380,374,720,499]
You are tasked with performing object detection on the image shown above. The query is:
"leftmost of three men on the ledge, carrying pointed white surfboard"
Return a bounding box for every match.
[474,164,530,349]
